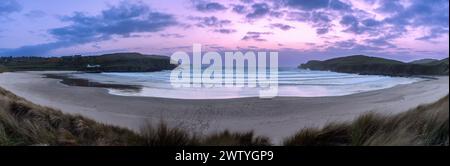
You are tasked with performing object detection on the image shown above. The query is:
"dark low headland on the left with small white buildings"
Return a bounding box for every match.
[0,53,176,72]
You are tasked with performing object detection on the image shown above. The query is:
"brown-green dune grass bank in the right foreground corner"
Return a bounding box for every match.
[283,96,449,146]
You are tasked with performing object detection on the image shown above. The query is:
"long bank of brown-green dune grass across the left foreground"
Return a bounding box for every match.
[0,88,270,146]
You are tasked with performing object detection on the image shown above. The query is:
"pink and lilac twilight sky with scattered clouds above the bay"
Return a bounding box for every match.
[0,0,449,66]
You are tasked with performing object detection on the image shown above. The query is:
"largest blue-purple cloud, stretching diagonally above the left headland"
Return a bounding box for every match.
[0,1,177,56]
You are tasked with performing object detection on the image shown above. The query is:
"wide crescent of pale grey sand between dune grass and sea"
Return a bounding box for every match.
[0,72,449,144]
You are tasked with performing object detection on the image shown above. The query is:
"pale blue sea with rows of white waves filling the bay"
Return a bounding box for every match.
[67,68,422,99]
